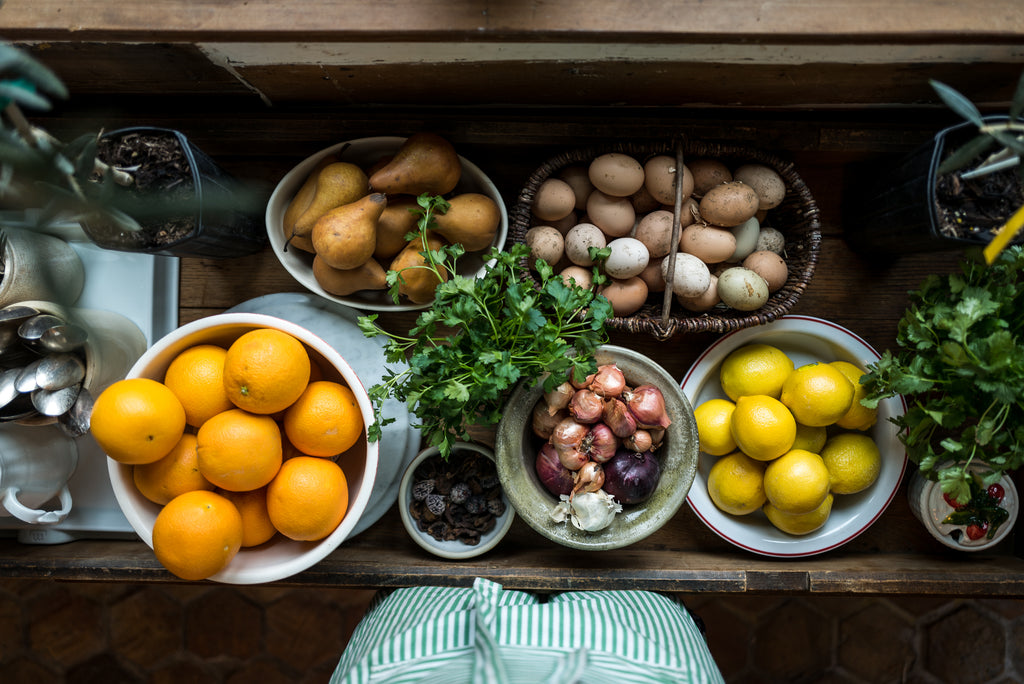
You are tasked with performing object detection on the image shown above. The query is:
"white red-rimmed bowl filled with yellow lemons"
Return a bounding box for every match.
[682,315,906,558]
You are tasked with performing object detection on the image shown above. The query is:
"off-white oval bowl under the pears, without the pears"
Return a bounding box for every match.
[266,136,508,311]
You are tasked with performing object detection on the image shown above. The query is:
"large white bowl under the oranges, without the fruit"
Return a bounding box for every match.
[106,313,378,585]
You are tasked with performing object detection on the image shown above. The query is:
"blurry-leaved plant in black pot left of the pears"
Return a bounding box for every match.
[0,44,266,258]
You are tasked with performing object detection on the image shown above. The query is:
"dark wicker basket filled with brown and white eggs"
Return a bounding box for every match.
[509,140,821,340]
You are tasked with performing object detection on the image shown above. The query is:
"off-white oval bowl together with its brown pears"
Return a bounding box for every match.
[266,133,508,311]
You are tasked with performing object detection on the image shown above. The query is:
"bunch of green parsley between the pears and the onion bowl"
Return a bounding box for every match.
[358,195,611,459]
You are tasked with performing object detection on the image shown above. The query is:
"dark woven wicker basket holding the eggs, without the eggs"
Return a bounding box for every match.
[509,140,821,340]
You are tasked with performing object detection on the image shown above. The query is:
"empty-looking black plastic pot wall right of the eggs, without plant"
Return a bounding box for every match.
[843,117,1007,258]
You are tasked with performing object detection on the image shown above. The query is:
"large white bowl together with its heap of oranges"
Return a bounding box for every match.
[90,313,378,585]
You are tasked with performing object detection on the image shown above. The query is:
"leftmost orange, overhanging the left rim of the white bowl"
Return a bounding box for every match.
[89,378,185,464]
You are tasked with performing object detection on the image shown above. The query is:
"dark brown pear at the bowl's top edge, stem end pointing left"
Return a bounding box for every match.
[370,133,462,195]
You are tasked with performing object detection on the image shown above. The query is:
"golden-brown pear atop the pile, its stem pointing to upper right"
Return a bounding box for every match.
[312,193,387,270]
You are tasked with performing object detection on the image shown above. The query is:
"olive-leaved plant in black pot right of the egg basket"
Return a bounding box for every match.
[844,73,1024,257]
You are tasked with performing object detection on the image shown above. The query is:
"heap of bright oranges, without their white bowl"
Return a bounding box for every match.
[90,328,364,580]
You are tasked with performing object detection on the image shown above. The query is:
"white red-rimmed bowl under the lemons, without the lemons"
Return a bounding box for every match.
[682,315,906,558]
